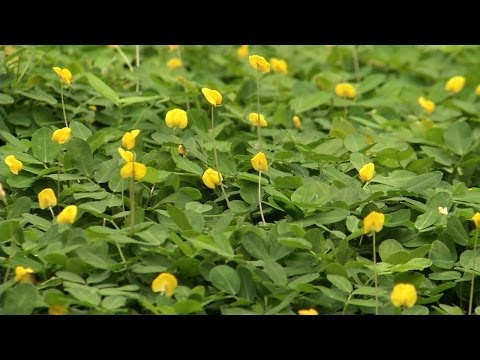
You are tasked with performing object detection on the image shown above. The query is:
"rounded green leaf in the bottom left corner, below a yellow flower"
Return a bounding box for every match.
[3,283,38,315]
